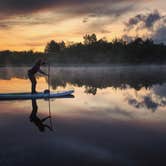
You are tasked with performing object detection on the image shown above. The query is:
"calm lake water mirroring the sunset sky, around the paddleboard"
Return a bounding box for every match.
[0,66,166,166]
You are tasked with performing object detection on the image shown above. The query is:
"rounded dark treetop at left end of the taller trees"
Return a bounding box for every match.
[45,40,60,53]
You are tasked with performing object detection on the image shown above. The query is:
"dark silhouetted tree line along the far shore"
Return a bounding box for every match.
[0,34,166,65]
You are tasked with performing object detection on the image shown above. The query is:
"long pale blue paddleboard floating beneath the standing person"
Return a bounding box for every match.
[0,90,74,100]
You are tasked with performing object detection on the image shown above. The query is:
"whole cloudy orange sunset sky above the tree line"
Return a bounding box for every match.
[0,0,166,51]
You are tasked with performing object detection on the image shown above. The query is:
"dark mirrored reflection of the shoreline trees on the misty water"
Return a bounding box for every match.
[0,66,166,94]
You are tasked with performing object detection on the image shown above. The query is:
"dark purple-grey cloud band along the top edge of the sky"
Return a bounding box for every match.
[0,0,143,18]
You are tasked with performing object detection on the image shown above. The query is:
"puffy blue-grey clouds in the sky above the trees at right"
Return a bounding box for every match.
[123,10,166,43]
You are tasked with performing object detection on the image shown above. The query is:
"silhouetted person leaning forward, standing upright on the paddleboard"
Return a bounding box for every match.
[28,59,48,94]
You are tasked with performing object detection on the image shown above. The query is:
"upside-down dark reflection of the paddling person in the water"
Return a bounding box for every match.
[29,99,52,132]
